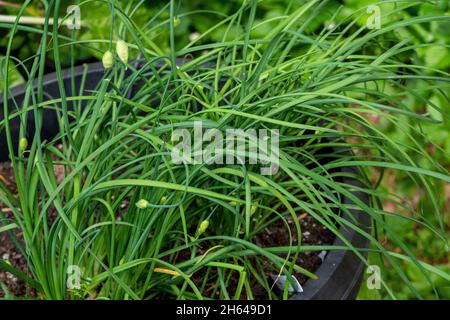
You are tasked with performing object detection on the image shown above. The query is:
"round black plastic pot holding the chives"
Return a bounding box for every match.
[0,63,371,300]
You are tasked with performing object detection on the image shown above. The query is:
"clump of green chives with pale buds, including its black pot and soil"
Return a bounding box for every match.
[0,1,450,299]
